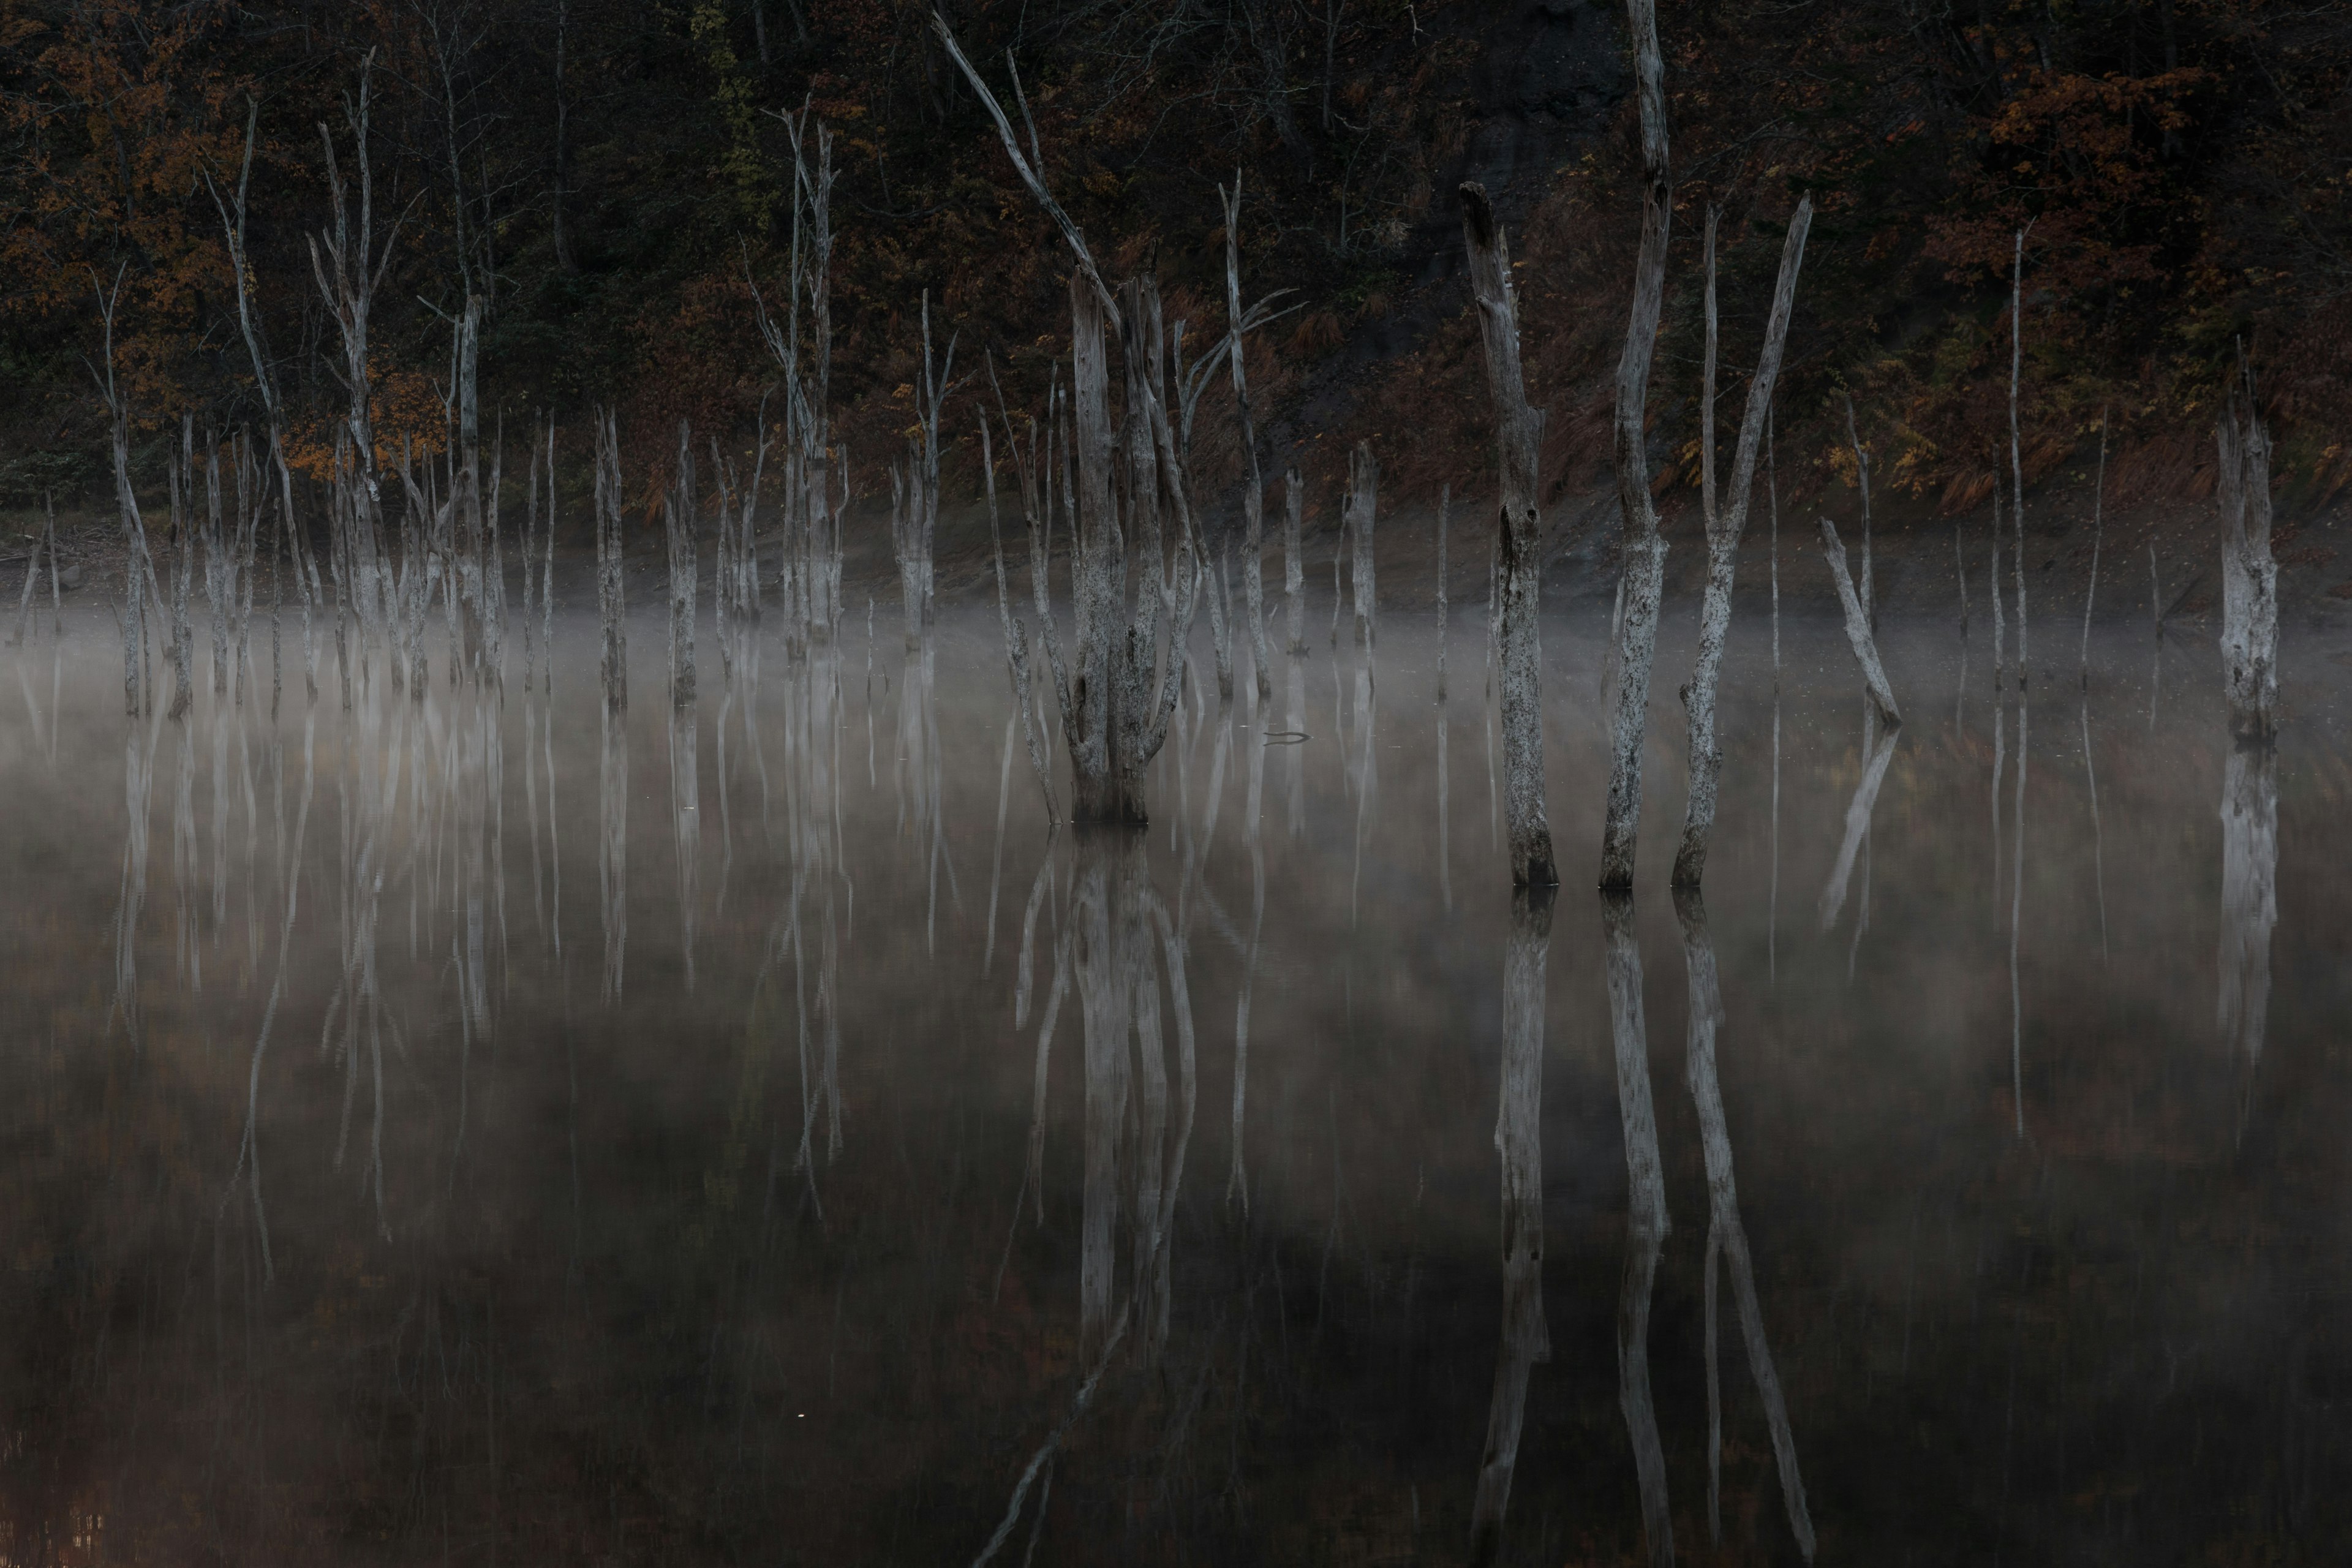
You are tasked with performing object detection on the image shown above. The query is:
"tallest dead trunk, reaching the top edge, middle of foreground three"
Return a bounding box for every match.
[1602,0,1675,889]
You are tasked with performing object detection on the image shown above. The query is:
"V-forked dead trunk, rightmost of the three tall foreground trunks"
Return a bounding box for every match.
[1675,197,1814,886]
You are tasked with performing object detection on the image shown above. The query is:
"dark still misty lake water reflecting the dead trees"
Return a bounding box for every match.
[0,597,2352,1563]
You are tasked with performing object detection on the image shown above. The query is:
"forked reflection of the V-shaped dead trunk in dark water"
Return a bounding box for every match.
[1675,889,1814,1561]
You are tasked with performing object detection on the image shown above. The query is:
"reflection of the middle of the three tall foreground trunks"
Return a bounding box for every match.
[1602,893,1675,1563]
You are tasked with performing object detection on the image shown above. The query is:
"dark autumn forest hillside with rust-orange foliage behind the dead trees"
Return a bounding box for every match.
[0,0,2352,526]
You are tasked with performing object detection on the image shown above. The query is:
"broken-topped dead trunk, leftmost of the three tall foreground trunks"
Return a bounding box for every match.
[1461,183,1552,886]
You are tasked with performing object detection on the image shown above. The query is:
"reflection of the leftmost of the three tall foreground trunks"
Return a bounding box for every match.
[1470,886,1555,1563]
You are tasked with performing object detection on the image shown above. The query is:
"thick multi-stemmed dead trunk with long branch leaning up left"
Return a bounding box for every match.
[932,12,1204,823]
